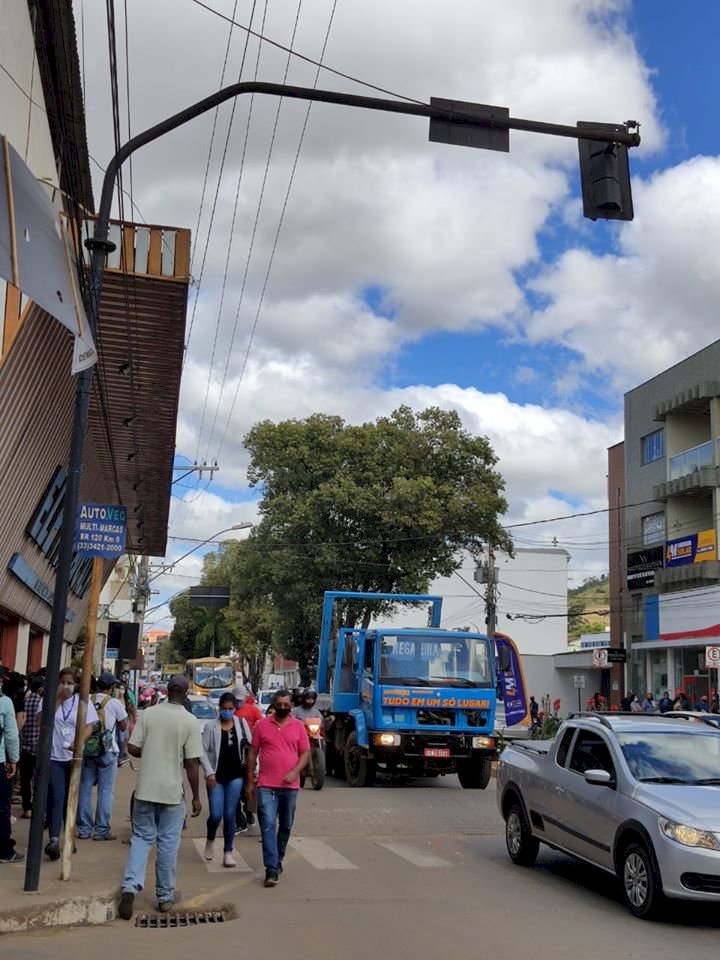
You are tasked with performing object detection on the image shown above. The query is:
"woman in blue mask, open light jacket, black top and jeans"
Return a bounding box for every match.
[200,693,251,867]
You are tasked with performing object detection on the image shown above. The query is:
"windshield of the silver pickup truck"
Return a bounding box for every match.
[617,727,720,784]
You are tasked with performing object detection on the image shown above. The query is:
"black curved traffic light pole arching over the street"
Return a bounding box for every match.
[24,81,640,891]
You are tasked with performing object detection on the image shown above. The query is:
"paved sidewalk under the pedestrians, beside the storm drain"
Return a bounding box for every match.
[0,764,253,942]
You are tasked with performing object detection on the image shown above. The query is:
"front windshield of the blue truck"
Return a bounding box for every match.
[380,634,492,687]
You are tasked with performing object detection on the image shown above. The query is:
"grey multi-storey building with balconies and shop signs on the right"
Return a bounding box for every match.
[608,341,720,701]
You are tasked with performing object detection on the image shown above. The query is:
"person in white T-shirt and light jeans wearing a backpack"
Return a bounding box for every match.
[77,673,128,840]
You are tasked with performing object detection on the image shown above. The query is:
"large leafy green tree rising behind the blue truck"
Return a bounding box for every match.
[245,407,512,679]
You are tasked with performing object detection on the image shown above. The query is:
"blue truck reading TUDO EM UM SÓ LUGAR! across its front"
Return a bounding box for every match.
[317,591,510,790]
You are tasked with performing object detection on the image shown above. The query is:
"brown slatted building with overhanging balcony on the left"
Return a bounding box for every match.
[0,0,190,671]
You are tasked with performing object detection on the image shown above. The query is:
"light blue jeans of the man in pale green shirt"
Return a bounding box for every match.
[122,798,185,903]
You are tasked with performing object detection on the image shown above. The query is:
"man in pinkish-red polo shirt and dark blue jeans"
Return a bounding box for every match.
[247,690,310,887]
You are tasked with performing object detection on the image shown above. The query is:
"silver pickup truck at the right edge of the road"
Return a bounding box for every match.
[497,713,720,918]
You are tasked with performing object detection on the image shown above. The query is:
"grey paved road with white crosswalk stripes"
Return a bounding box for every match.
[0,777,720,960]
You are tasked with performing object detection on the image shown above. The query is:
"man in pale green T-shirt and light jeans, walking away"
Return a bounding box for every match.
[118,676,203,920]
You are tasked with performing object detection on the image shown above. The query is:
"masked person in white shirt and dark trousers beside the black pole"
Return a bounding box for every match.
[40,667,98,860]
